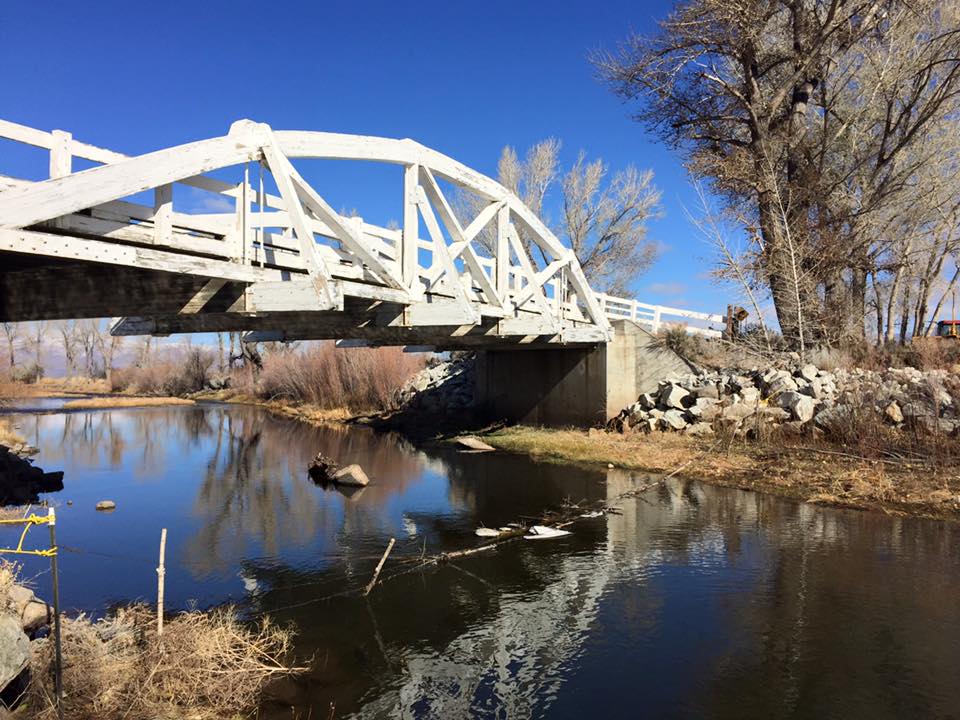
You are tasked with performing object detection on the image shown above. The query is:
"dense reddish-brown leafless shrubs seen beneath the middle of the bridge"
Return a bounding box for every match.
[256,342,424,410]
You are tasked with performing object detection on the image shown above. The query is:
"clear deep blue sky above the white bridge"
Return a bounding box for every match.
[0,0,733,312]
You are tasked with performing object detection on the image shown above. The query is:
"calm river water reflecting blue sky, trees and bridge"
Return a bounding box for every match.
[1,405,960,719]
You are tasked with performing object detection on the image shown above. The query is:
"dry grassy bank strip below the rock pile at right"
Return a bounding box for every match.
[478,426,960,521]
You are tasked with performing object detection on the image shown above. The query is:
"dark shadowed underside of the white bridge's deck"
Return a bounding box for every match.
[0,253,599,349]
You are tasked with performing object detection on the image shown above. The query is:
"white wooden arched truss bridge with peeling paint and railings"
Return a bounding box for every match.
[0,120,724,348]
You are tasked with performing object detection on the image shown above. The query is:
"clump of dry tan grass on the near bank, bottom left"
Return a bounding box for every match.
[27,606,297,720]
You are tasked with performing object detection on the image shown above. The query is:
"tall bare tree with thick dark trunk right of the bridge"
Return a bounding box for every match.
[594,0,960,345]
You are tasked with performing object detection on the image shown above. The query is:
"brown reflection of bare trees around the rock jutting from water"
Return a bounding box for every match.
[186,407,428,575]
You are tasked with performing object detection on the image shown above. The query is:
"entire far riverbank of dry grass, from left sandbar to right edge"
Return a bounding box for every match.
[7,376,960,520]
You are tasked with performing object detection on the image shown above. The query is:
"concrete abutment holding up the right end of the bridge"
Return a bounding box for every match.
[476,320,691,427]
